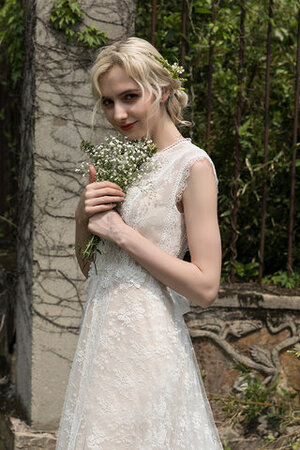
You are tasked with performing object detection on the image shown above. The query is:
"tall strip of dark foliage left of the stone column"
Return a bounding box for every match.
[0,0,25,248]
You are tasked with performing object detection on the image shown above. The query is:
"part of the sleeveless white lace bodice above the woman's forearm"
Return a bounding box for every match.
[121,139,218,257]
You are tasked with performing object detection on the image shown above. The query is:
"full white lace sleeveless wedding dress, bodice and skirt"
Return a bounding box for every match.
[56,139,222,450]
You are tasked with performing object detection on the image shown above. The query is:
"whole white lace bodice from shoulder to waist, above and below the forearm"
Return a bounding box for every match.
[89,139,218,312]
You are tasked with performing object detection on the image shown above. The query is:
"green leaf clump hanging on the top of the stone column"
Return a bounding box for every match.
[49,0,108,49]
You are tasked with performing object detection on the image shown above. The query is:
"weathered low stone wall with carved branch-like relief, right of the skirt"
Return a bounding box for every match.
[185,287,300,442]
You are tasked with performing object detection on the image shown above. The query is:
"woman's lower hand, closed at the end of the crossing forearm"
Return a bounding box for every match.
[88,207,126,242]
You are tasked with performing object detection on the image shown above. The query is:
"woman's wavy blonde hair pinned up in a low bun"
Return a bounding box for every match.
[91,37,190,126]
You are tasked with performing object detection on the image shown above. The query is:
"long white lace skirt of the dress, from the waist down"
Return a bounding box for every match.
[56,258,222,450]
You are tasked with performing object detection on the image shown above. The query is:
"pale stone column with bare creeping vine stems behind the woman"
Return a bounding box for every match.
[16,0,135,431]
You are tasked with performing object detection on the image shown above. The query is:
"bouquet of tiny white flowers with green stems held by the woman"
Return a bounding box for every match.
[75,137,157,262]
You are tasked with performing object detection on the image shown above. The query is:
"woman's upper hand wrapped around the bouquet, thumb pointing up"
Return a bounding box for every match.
[75,166,125,224]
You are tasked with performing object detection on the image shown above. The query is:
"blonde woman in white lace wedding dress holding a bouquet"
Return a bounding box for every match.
[57,38,222,450]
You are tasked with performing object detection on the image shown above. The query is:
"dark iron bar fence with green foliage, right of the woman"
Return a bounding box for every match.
[136,0,300,283]
